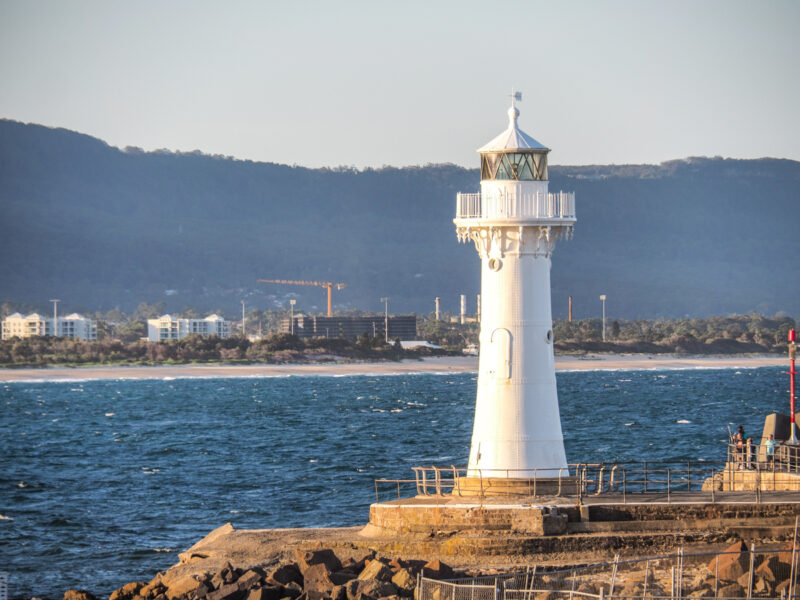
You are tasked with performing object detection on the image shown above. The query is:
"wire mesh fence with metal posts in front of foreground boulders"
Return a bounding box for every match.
[415,542,800,600]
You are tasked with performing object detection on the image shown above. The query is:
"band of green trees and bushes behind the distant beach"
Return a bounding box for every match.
[0,312,797,367]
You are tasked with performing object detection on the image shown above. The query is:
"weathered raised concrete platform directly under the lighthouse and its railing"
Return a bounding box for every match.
[367,492,800,537]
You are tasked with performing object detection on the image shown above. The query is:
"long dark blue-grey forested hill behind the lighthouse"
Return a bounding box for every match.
[0,120,800,318]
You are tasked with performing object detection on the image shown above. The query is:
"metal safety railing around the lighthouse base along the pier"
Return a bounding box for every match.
[375,461,784,503]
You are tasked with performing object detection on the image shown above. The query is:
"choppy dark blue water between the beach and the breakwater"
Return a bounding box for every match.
[0,368,788,599]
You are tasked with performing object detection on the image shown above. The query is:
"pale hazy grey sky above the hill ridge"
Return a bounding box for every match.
[0,0,800,167]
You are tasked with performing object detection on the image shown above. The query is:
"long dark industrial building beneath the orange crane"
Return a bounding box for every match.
[281,315,417,341]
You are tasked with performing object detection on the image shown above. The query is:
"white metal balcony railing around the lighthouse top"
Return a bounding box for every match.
[456,190,575,219]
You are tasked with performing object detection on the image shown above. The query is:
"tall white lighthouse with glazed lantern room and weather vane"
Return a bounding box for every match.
[453,94,575,479]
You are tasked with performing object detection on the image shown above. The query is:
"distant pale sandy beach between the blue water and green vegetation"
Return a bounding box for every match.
[0,354,787,382]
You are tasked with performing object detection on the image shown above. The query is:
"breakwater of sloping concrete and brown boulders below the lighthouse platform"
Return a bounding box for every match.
[64,502,800,600]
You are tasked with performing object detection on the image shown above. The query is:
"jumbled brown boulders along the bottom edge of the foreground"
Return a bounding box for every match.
[64,541,796,600]
